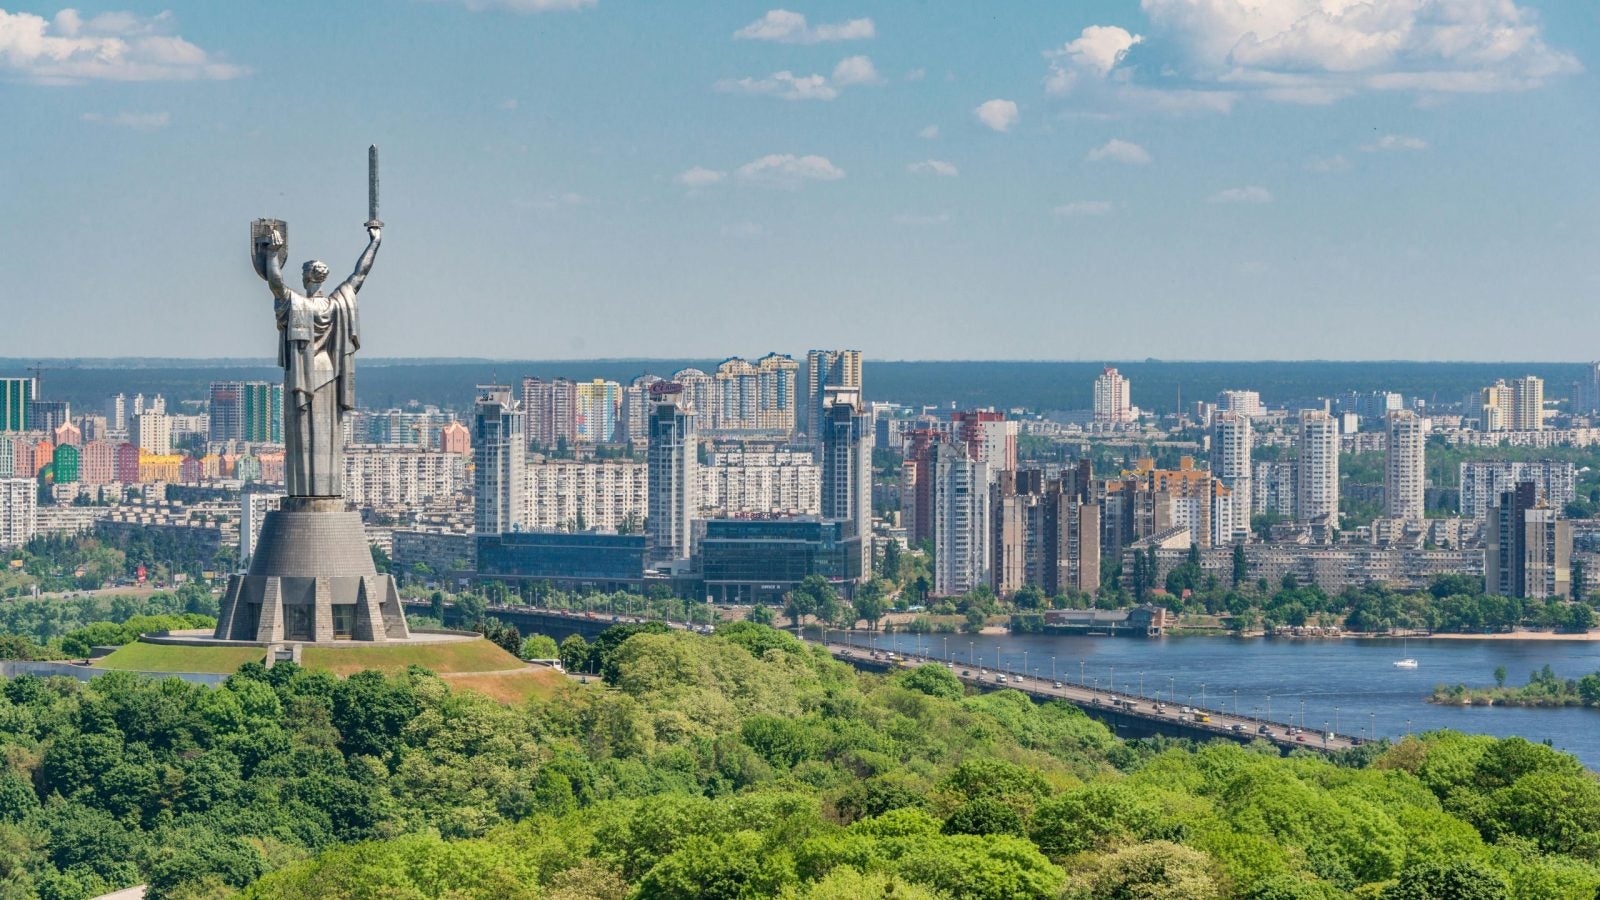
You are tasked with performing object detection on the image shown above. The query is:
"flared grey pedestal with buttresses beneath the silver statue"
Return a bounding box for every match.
[216,496,411,642]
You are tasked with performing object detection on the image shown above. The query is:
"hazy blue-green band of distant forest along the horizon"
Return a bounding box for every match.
[12,351,1587,413]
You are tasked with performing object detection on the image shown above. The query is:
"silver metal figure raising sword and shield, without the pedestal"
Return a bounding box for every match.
[251,147,382,498]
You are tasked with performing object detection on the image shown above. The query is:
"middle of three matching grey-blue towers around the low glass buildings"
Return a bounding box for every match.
[645,381,699,570]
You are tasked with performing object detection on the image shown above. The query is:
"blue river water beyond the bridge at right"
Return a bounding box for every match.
[850,634,1600,770]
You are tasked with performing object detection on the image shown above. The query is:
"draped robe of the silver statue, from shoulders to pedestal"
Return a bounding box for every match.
[274,282,362,496]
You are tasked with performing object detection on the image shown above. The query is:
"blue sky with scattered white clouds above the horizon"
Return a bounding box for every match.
[0,0,1600,360]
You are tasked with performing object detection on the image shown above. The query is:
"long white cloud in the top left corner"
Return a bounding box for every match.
[0,10,248,85]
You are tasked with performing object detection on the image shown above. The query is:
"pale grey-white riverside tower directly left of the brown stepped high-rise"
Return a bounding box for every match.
[931,444,990,597]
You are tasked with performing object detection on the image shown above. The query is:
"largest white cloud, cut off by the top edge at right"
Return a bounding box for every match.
[1141,0,1582,102]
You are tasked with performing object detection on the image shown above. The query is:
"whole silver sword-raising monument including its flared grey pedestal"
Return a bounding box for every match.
[216,147,410,644]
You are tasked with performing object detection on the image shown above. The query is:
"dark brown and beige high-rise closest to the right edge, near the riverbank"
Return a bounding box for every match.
[1483,482,1573,597]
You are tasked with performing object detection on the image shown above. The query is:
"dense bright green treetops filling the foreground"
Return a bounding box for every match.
[0,623,1600,900]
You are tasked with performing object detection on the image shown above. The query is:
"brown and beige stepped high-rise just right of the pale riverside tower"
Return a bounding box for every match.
[989,460,1101,596]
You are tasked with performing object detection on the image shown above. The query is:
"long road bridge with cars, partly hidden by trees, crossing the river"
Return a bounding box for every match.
[405,601,1363,753]
